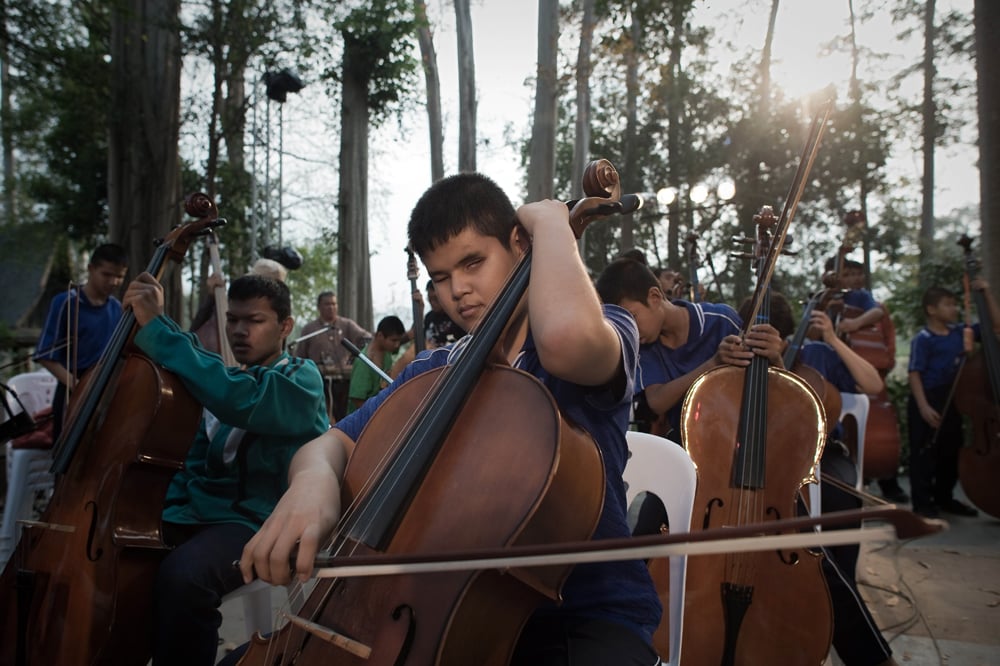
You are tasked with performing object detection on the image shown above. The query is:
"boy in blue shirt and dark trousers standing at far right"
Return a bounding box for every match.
[906,279,1000,517]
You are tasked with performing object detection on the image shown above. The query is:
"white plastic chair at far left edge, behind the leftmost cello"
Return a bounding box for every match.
[0,370,58,570]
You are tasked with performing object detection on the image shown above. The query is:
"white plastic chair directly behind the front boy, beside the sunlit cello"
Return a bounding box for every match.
[623,431,698,666]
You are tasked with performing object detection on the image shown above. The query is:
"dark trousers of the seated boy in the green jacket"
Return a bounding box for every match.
[153,523,254,666]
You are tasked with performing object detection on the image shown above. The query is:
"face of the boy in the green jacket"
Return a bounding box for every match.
[226,296,295,365]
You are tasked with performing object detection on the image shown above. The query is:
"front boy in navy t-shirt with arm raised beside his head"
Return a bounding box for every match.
[241,174,661,666]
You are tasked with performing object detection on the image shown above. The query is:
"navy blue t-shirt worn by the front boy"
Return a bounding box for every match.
[334,305,663,641]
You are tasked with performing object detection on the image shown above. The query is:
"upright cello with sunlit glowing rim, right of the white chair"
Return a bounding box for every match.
[681,105,833,666]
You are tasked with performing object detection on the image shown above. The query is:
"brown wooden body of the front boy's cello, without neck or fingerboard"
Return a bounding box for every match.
[240,366,604,666]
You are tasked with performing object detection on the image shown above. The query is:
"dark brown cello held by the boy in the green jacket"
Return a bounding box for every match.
[0,195,221,666]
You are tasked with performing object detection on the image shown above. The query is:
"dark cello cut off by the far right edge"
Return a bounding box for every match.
[954,234,1000,518]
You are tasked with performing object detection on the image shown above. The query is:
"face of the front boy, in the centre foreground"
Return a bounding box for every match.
[421,227,520,331]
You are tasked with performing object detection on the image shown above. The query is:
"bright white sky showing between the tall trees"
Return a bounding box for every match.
[272,0,979,322]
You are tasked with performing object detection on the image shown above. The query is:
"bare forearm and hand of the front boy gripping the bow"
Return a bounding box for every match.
[240,429,354,585]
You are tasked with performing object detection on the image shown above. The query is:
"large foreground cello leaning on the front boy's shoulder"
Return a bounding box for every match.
[235,161,638,666]
